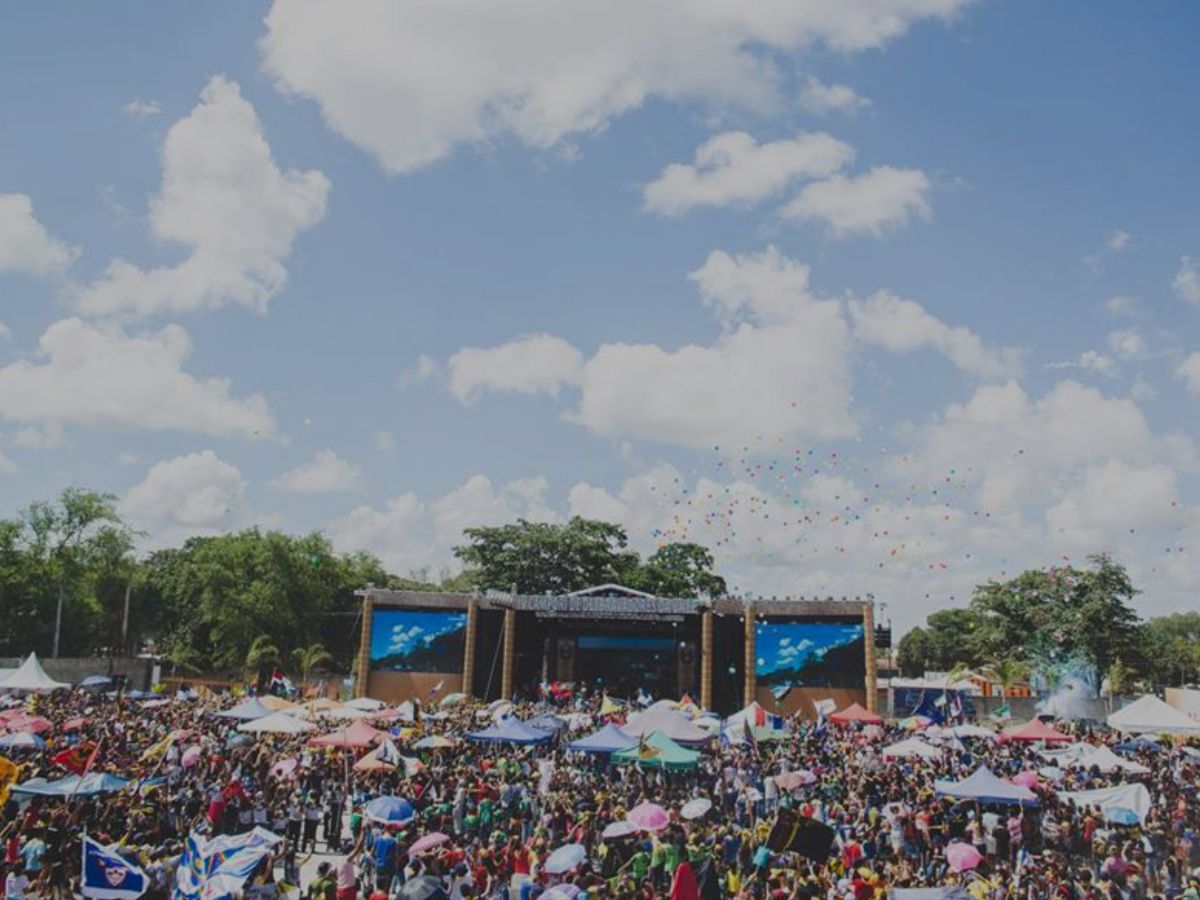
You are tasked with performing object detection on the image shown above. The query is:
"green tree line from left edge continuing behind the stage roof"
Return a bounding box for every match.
[0,488,725,676]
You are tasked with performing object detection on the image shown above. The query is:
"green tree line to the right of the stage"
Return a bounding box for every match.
[896,556,1200,692]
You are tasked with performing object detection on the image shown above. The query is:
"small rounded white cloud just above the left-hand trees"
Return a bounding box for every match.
[119,450,246,542]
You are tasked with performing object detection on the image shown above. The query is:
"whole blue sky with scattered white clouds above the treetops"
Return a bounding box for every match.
[0,0,1200,626]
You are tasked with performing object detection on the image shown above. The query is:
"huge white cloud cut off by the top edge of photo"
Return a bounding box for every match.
[259,0,968,173]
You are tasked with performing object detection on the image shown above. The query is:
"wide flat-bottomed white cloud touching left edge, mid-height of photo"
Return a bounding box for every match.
[0,318,277,437]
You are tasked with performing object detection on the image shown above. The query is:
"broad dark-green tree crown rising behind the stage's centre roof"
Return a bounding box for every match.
[454,516,638,594]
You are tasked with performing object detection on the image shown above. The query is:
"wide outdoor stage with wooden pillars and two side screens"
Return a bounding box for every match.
[356,586,875,716]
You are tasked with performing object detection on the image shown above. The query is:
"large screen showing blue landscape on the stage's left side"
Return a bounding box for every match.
[371,610,467,672]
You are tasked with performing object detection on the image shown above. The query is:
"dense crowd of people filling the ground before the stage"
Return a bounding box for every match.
[0,690,1200,900]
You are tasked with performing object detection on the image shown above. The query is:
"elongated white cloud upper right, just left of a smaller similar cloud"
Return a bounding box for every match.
[642,131,854,216]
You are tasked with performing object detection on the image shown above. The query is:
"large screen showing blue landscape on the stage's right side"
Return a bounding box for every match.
[755,622,865,688]
